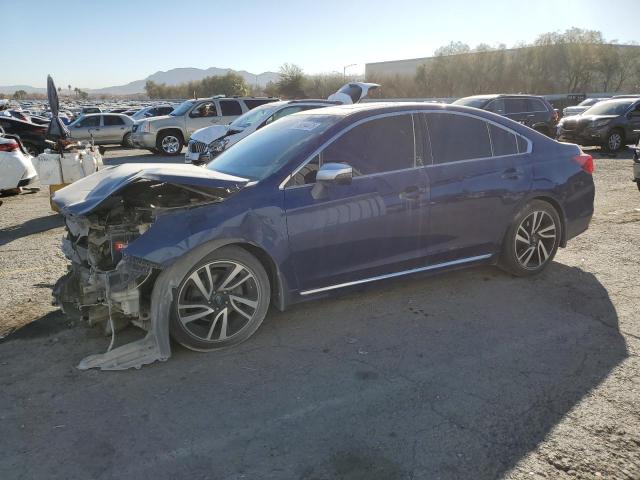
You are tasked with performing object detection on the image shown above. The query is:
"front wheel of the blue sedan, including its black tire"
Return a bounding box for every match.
[169,246,271,352]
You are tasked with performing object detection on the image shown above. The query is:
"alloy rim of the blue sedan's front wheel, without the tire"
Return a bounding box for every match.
[177,261,260,342]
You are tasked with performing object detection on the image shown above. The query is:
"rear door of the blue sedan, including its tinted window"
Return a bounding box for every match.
[423,112,532,263]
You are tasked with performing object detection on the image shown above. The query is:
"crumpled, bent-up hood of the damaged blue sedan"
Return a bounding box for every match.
[53,163,248,215]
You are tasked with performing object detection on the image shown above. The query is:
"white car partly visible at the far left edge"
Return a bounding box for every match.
[0,129,38,193]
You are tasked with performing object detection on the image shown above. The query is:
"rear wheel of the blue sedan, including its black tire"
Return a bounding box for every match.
[499,200,562,277]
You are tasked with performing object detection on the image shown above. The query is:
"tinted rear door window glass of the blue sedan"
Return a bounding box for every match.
[426,113,491,164]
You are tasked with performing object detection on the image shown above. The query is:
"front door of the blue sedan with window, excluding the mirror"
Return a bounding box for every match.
[284,113,428,294]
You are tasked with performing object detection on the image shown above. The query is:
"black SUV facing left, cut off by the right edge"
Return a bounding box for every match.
[558,98,640,152]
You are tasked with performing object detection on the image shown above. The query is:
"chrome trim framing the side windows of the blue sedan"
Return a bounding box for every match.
[278,109,533,190]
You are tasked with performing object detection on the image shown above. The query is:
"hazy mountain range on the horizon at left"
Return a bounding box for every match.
[0,67,280,95]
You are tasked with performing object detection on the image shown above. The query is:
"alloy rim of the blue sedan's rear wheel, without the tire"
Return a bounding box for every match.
[514,210,558,270]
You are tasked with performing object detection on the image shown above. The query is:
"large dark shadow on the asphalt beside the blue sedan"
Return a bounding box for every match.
[0,263,627,480]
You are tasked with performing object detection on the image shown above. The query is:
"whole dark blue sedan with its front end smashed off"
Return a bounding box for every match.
[54,103,594,369]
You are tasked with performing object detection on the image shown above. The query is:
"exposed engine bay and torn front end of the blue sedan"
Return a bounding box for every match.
[53,178,238,368]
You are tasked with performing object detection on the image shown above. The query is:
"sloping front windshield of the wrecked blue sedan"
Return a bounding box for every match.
[207,114,342,180]
